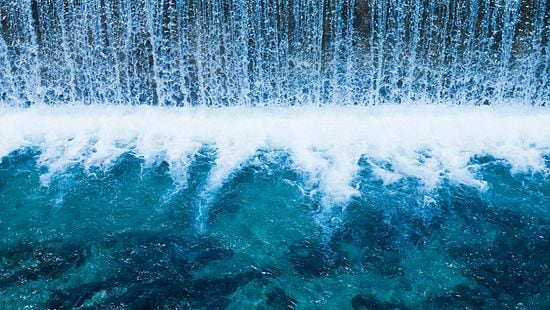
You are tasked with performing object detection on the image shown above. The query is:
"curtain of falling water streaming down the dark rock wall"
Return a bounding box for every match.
[0,0,550,106]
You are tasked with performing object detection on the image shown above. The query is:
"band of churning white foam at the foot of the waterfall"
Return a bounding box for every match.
[0,105,550,203]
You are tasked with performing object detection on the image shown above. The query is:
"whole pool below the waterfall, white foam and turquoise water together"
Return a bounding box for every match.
[0,107,550,309]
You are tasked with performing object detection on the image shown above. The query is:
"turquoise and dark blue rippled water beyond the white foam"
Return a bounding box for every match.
[0,106,550,309]
